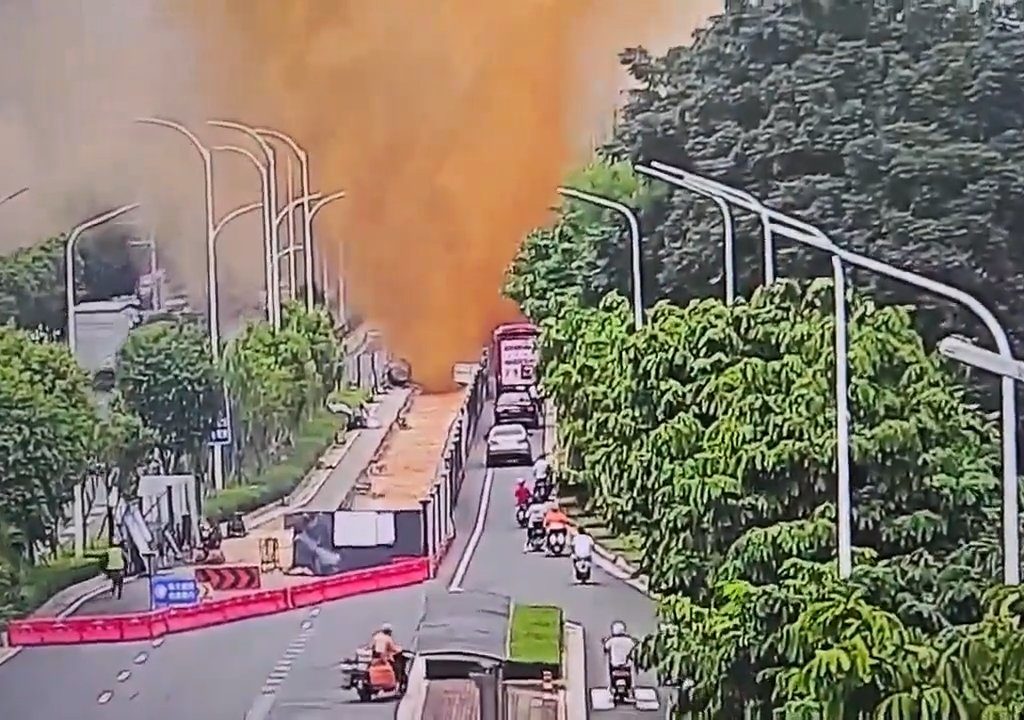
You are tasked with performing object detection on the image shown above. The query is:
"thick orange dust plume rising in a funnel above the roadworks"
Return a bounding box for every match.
[182,0,722,390]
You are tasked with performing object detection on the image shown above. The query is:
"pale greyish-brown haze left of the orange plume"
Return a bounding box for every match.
[0,0,262,320]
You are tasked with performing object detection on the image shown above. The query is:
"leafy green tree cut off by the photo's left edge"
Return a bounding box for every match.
[0,327,96,554]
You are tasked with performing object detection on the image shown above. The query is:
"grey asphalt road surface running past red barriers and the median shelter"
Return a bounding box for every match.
[0,403,656,720]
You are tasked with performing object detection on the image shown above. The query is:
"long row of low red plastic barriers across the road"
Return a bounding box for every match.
[7,557,431,646]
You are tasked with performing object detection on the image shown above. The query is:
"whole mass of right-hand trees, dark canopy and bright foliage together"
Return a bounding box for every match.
[506,0,1024,708]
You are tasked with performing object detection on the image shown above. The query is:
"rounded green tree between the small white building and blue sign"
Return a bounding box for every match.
[115,320,221,475]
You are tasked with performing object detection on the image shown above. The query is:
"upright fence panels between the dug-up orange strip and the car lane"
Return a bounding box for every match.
[420,365,487,577]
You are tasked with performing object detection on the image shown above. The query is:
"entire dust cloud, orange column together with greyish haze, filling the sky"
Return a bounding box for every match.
[0,0,722,390]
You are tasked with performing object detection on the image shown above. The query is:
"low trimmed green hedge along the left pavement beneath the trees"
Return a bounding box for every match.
[203,410,345,522]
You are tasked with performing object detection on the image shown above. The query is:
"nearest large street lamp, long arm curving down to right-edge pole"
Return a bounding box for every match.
[651,161,1020,585]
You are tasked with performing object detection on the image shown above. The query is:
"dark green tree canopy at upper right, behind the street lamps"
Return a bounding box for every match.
[557,0,1024,354]
